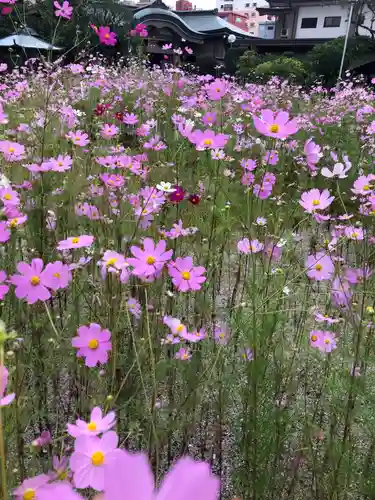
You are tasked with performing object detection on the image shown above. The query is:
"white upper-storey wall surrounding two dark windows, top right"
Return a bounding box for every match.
[296,4,349,38]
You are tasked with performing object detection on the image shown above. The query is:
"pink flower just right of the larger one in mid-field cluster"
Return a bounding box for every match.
[168,257,206,292]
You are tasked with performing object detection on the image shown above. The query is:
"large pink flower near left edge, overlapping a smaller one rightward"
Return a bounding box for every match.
[10,259,51,304]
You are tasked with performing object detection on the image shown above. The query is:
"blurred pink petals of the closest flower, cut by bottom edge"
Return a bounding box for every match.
[104,450,220,500]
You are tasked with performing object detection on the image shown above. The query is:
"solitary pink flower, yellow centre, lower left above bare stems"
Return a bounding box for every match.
[72,323,112,368]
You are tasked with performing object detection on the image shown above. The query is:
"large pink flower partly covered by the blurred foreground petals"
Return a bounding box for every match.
[70,431,122,490]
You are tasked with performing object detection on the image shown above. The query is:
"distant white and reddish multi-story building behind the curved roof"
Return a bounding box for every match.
[216,0,274,36]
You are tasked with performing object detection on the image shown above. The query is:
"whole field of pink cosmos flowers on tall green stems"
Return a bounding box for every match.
[0,52,375,500]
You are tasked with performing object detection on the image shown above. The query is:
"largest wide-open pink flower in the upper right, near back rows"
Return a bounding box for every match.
[253,109,299,139]
